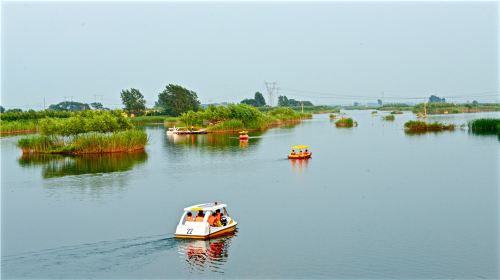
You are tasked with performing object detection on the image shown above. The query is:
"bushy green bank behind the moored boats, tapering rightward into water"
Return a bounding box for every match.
[179,104,312,132]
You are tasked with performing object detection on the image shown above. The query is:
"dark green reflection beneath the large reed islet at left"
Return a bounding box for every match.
[19,151,148,178]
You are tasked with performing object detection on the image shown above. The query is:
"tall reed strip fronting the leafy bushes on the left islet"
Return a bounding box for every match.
[17,130,148,155]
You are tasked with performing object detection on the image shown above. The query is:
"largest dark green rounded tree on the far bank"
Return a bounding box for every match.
[156,84,200,116]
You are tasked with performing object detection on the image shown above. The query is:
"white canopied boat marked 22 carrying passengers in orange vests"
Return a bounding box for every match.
[175,202,238,239]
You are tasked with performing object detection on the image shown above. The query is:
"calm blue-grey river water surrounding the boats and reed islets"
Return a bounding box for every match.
[1,111,499,279]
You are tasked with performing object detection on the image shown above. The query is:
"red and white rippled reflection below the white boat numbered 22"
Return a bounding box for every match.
[178,233,235,273]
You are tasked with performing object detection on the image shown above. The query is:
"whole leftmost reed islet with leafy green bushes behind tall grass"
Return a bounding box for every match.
[17,111,148,155]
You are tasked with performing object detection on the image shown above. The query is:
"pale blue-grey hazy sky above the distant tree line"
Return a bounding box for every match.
[1,1,499,109]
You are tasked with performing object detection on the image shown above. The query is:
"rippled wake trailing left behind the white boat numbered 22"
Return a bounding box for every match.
[2,235,178,278]
